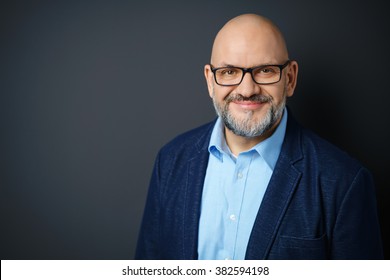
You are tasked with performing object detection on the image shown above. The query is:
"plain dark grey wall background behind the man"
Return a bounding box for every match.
[0,0,390,259]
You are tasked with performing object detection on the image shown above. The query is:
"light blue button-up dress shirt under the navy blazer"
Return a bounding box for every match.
[198,110,287,260]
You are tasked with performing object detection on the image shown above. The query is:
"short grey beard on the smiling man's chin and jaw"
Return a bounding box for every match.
[213,92,286,138]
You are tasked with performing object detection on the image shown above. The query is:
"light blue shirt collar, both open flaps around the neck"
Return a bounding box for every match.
[208,109,287,170]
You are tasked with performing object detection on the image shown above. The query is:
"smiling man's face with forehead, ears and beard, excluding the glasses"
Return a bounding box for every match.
[205,20,297,137]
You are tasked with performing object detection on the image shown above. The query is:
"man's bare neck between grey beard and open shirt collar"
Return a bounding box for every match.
[225,118,281,156]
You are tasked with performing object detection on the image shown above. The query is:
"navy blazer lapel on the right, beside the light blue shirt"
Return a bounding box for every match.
[245,114,302,259]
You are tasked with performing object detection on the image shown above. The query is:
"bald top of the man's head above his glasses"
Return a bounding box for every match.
[211,14,288,67]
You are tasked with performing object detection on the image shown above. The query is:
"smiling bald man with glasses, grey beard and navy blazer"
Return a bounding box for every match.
[136,14,383,259]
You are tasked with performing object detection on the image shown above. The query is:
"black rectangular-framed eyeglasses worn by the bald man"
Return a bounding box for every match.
[210,60,290,86]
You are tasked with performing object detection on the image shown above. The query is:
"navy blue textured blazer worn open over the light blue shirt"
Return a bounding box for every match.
[135,113,383,260]
